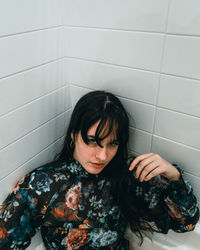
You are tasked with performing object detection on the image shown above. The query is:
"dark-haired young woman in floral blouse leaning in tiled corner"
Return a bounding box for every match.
[0,91,199,250]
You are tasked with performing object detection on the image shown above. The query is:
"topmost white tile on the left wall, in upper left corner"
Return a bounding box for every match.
[0,0,62,37]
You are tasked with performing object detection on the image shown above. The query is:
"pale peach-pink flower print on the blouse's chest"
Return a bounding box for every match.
[66,183,81,210]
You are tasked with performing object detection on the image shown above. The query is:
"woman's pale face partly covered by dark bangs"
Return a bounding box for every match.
[73,121,119,174]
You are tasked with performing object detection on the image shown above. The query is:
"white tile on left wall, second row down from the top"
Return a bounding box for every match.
[0,28,63,78]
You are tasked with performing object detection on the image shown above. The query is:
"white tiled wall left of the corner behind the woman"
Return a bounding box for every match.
[0,0,71,202]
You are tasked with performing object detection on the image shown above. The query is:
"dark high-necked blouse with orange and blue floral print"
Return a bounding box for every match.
[0,161,199,250]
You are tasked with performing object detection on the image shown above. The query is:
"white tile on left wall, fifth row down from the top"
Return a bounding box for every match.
[0,113,66,180]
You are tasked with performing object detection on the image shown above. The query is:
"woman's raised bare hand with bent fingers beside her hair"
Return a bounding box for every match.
[129,153,180,182]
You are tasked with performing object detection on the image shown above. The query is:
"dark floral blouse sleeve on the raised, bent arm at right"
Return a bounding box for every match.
[131,162,199,233]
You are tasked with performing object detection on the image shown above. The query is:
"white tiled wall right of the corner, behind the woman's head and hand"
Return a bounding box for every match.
[63,0,200,209]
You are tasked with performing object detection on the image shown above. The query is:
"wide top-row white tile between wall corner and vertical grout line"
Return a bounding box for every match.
[64,0,169,32]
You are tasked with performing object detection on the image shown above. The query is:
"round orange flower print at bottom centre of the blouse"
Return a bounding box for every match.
[65,229,89,249]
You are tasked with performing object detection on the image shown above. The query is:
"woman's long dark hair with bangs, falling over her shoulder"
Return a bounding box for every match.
[56,91,155,243]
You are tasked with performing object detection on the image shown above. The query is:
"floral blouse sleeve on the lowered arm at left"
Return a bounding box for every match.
[0,169,53,249]
